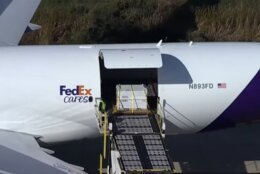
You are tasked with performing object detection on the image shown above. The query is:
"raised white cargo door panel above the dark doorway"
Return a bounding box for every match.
[100,48,162,69]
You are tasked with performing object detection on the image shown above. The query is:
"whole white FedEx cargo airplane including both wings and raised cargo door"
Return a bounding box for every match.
[0,0,260,173]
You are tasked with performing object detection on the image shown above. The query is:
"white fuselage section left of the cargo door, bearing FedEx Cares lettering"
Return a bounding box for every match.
[0,46,100,142]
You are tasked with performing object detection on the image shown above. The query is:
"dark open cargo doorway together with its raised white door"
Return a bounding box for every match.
[99,49,162,110]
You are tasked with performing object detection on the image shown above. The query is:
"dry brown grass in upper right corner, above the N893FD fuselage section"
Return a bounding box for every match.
[190,0,260,41]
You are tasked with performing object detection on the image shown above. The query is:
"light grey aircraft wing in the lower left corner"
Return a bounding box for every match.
[0,130,86,174]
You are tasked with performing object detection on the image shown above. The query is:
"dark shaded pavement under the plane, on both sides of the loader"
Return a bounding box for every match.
[47,124,260,173]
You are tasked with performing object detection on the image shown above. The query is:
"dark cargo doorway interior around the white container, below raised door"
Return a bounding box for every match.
[100,60,158,110]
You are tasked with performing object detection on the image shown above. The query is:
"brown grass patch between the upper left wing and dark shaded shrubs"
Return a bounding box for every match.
[22,0,95,44]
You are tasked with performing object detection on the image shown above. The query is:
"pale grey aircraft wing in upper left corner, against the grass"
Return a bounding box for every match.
[0,0,41,46]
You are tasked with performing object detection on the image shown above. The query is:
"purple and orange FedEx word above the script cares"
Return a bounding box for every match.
[60,85,92,96]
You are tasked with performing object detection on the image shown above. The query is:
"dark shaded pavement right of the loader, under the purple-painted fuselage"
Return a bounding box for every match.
[166,125,260,173]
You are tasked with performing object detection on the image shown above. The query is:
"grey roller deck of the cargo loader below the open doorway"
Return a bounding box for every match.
[112,115,173,173]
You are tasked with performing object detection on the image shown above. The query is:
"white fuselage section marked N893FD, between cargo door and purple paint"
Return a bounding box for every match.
[158,43,260,134]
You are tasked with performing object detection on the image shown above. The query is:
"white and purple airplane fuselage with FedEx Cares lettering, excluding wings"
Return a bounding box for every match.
[0,43,260,142]
